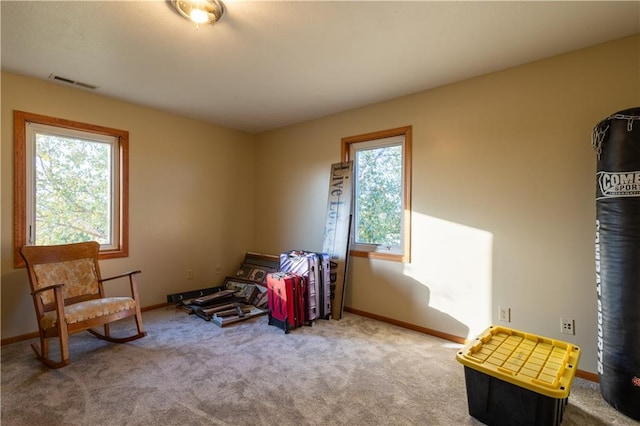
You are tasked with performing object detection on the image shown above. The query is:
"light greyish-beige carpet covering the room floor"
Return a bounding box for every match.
[1,307,638,426]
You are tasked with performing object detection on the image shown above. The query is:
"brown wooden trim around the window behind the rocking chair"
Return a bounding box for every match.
[13,111,129,268]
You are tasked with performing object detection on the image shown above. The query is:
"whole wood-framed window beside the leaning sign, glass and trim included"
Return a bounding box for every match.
[342,127,411,262]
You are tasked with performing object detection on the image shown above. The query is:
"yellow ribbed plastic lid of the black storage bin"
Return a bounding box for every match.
[456,326,580,399]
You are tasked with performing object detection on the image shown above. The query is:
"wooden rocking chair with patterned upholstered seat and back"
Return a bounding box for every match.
[20,241,147,368]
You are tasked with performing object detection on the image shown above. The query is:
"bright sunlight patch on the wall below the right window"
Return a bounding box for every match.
[404,212,493,338]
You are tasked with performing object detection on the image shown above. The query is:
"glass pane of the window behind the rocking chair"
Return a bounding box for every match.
[33,133,113,244]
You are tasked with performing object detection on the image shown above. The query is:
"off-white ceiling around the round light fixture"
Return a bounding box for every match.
[0,0,640,133]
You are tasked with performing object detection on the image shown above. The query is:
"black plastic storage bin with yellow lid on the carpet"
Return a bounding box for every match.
[456,326,580,426]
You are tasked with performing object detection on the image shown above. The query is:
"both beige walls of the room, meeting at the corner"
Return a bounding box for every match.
[0,35,640,372]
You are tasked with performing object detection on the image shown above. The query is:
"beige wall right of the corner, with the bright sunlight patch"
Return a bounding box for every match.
[254,36,640,372]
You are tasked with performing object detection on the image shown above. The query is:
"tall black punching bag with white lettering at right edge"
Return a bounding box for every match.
[592,107,640,420]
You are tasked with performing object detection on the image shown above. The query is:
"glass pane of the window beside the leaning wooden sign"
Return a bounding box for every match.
[354,145,403,248]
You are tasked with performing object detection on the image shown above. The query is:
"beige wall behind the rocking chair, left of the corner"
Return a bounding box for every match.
[1,73,255,338]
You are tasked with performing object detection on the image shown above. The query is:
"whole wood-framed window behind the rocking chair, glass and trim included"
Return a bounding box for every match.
[14,111,128,265]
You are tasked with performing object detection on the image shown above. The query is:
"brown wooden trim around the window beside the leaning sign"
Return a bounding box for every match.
[341,126,412,263]
